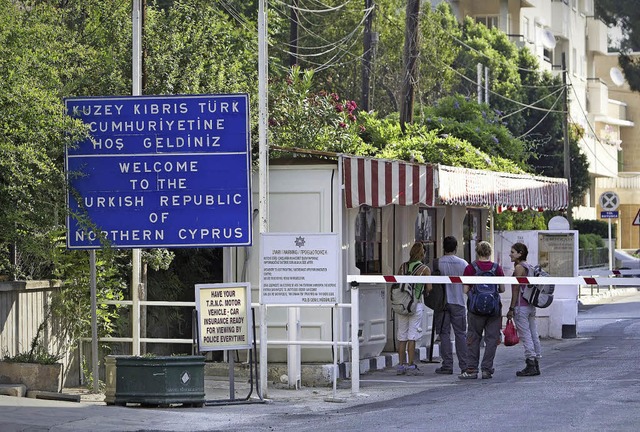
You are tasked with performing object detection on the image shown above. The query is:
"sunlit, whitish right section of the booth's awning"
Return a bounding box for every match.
[438,165,569,210]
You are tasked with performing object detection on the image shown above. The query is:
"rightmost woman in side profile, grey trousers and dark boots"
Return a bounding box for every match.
[507,243,542,376]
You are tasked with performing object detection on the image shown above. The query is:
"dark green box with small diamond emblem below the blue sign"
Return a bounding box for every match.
[105,355,205,407]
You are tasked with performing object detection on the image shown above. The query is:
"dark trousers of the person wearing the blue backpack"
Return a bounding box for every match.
[467,312,502,373]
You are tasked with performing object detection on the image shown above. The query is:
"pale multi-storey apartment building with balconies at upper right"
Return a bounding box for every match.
[431,0,640,249]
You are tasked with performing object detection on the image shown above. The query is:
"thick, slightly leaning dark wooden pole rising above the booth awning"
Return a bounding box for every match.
[400,0,420,133]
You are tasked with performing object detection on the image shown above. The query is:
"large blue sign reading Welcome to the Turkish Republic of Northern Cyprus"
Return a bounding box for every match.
[65,94,252,249]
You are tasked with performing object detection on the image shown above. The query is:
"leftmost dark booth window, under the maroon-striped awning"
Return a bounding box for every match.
[356,205,382,274]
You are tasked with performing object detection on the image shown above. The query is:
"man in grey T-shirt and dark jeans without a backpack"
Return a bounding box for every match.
[433,236,469,375]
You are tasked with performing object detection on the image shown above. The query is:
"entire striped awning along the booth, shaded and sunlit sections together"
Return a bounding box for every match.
[342,156,569,210]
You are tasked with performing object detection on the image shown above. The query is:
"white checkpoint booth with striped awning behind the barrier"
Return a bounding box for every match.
[225,155,569,372]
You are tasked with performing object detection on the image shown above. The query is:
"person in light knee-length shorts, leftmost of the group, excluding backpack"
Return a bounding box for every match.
[395,243,431,375]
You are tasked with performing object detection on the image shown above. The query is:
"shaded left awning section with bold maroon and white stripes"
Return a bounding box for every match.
[342,156,435,208]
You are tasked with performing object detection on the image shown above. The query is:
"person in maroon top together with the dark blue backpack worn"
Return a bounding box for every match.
[458,241,504,379]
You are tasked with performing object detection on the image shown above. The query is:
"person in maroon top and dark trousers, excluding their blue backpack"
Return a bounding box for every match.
[458,241,504,379]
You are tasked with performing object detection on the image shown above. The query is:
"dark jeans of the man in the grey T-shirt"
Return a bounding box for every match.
[434,303,467,371]
